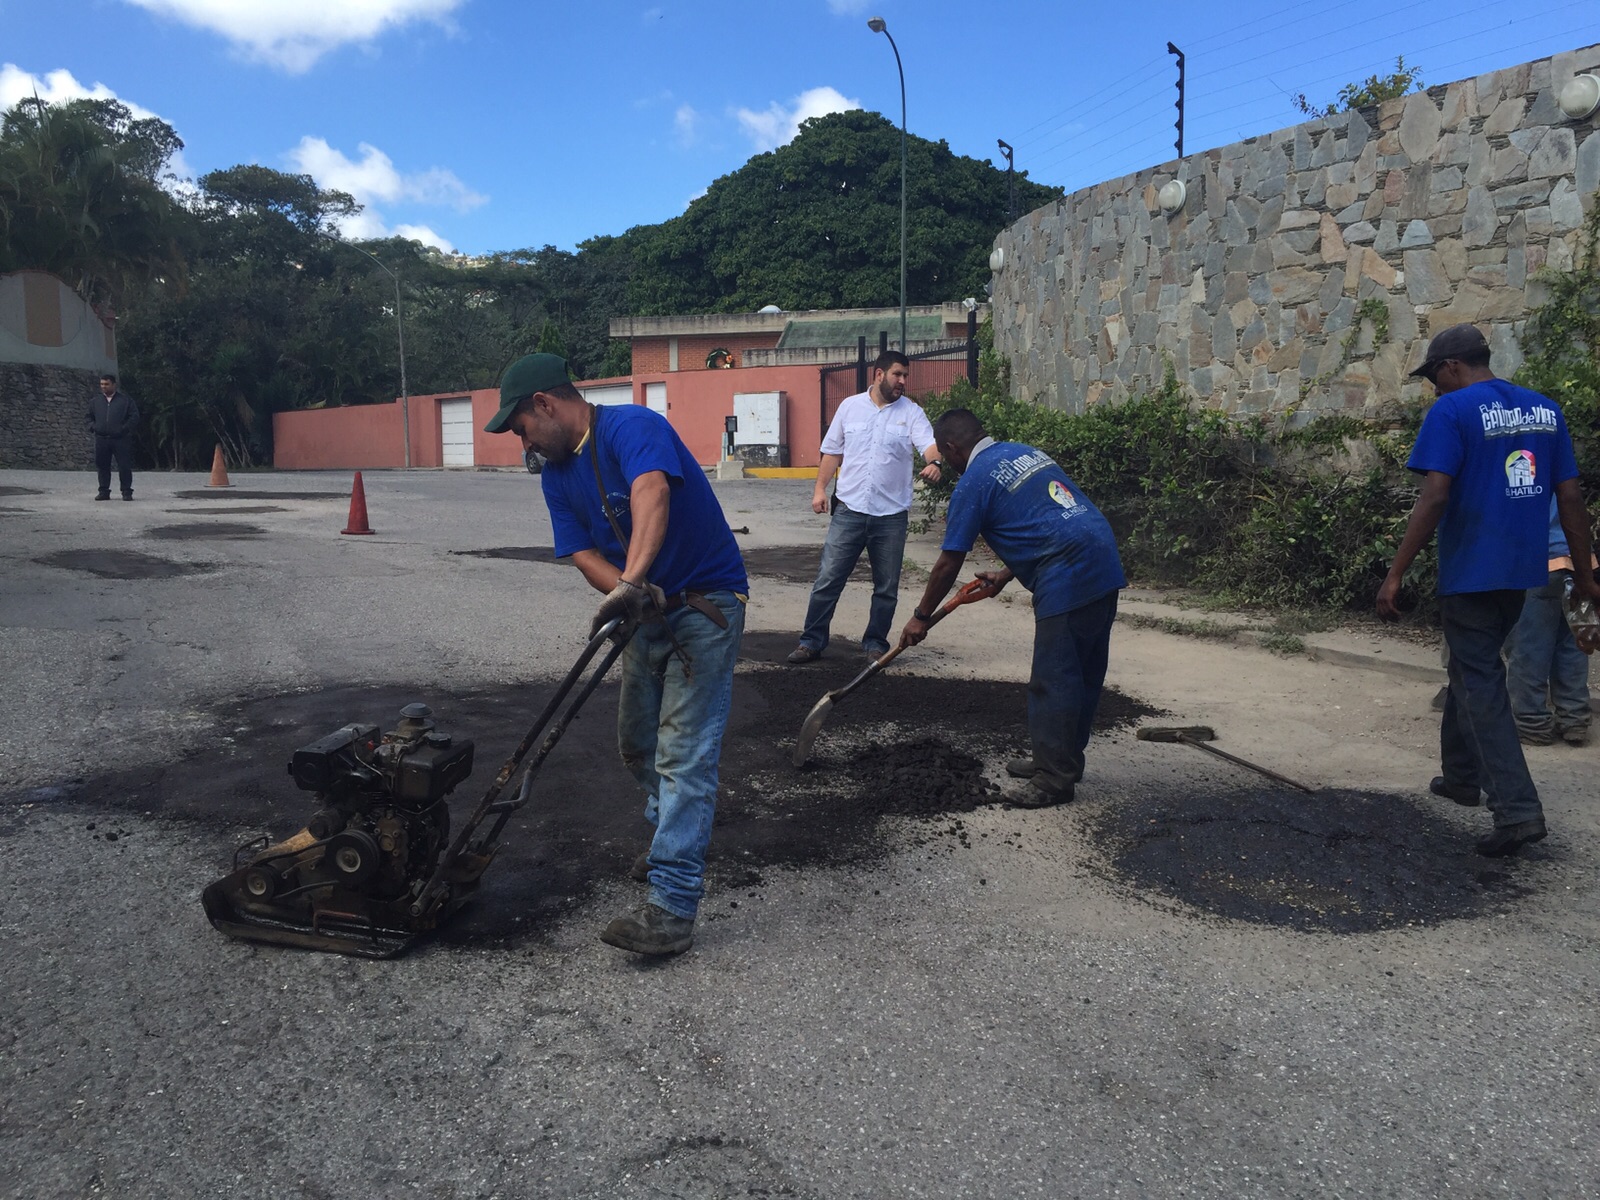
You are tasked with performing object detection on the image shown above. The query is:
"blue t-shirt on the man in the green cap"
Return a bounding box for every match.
[539,405,750,595]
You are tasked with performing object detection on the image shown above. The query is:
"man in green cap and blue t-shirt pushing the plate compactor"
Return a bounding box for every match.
[483,354,749,955]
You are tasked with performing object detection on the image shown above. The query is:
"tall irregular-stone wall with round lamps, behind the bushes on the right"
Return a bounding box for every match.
[992,46,1600,414]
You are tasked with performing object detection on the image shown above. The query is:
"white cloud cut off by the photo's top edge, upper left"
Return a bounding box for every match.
[126,0,466,74]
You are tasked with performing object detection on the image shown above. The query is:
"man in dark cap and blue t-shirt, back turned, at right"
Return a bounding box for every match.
[1378,325,1600,858]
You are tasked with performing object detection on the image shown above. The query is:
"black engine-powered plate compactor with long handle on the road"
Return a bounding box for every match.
[202,621,630,958]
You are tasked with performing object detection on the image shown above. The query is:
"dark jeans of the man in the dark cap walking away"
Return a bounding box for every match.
[1438,590,1544,826]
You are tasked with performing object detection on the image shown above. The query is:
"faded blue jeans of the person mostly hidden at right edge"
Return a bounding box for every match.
[1506,571,1589,734]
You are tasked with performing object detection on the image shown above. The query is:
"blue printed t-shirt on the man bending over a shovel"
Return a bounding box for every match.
[942,442,1128,619]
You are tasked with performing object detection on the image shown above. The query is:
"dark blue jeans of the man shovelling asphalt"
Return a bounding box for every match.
[1027,592,1117,794]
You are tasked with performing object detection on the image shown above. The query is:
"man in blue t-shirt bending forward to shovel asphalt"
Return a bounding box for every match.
[899,408,1128,808]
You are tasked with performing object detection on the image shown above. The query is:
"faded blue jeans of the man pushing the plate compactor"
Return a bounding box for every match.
[616,592,744,920]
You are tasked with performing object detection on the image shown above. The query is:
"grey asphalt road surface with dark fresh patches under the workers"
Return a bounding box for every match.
[0,472,1600,1200]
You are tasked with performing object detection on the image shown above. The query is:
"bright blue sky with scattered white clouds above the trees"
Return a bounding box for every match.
[0,0,1600,254]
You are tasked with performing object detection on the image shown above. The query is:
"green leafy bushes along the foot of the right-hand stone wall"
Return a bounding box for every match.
[925,321,1434,611]
